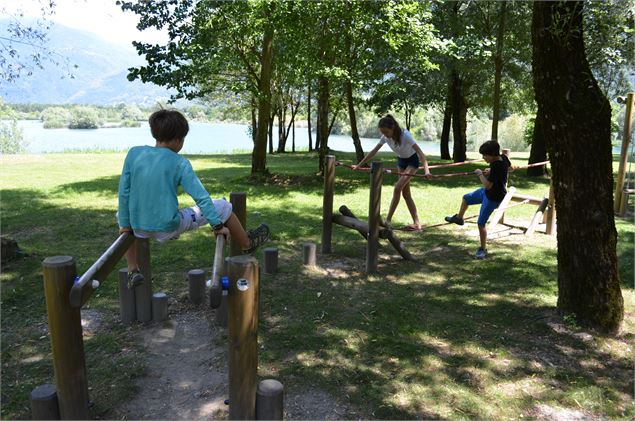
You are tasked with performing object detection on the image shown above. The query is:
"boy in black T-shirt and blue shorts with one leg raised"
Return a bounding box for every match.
[445,140,511,259]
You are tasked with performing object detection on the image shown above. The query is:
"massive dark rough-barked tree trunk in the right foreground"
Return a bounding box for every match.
[532,1,624,333]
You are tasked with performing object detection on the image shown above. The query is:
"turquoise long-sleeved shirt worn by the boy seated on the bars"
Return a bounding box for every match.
[118,146,222,232]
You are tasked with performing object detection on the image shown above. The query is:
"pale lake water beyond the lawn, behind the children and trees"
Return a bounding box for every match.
[13,120,439,155]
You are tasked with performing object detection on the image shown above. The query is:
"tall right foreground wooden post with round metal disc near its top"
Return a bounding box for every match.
[228,255,259,420]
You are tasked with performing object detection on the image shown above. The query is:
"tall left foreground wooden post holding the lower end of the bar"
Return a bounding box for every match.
[42,256,88,420]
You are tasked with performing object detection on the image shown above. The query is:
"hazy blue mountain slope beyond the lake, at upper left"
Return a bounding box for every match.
[0,20,170,105]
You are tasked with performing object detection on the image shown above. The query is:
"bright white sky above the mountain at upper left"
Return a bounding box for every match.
[2,0,167,45]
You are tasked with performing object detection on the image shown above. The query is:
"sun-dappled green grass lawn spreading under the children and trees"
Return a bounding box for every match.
[0,153,635,419]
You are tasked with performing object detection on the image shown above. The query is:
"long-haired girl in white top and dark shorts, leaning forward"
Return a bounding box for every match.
[353,114,430,231]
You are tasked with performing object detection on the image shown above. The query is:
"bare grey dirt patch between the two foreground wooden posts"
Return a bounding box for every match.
[118,308,228,420]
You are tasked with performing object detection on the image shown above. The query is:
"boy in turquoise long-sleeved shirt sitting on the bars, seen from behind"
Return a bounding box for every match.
[117,110,269,288]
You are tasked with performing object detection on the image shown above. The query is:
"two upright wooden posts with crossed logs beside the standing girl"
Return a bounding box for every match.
[322,155,414,273]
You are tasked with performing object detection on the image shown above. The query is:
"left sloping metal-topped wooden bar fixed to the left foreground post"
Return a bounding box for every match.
[69,232,134,308]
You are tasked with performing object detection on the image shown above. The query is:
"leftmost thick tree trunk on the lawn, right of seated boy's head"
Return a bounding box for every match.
[251,11,273,174]
